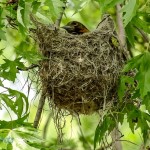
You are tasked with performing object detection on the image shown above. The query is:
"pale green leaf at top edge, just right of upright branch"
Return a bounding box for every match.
[121,0,138,27]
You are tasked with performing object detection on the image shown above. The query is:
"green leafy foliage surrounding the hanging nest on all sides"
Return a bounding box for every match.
[0,0,150,150]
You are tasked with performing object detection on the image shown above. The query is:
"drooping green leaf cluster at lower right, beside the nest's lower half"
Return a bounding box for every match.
[94,52,150,148]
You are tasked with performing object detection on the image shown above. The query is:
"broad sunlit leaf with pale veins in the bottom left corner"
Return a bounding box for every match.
[0,125,43,150]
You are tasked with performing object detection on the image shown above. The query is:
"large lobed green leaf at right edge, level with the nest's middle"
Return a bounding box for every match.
[123,52,150,98]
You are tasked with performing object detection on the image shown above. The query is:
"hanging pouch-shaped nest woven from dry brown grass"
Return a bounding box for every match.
[33,16,124,114]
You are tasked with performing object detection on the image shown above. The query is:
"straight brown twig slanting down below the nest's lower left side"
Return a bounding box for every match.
[33,88,46,128]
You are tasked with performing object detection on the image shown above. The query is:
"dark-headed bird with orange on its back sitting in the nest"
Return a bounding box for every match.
[61,21,90,35]
